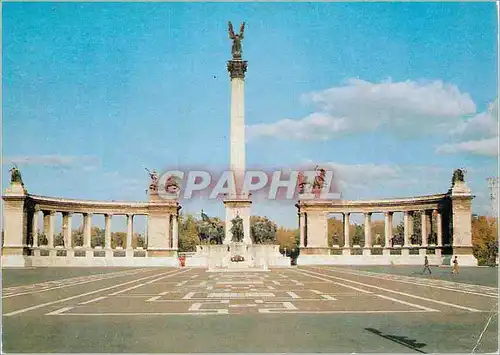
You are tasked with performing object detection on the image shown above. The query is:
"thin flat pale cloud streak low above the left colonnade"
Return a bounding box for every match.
[3,155,99,167]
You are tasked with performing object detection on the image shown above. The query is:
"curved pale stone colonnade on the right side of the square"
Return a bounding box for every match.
[296,181,477,266]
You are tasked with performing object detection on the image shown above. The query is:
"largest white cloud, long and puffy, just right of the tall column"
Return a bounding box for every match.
[248,79,476,140]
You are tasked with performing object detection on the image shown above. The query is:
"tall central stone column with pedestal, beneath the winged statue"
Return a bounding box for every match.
[224,43,252,244]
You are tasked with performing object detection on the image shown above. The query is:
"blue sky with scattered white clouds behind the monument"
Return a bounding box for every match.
[2,3,498,234]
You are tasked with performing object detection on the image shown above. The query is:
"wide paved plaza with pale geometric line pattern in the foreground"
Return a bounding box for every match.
[2,266,498,353]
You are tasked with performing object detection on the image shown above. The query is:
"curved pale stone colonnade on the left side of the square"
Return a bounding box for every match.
[2,183,180,267]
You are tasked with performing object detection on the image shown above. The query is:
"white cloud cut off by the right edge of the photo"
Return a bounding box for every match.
[436,99,498,157]
